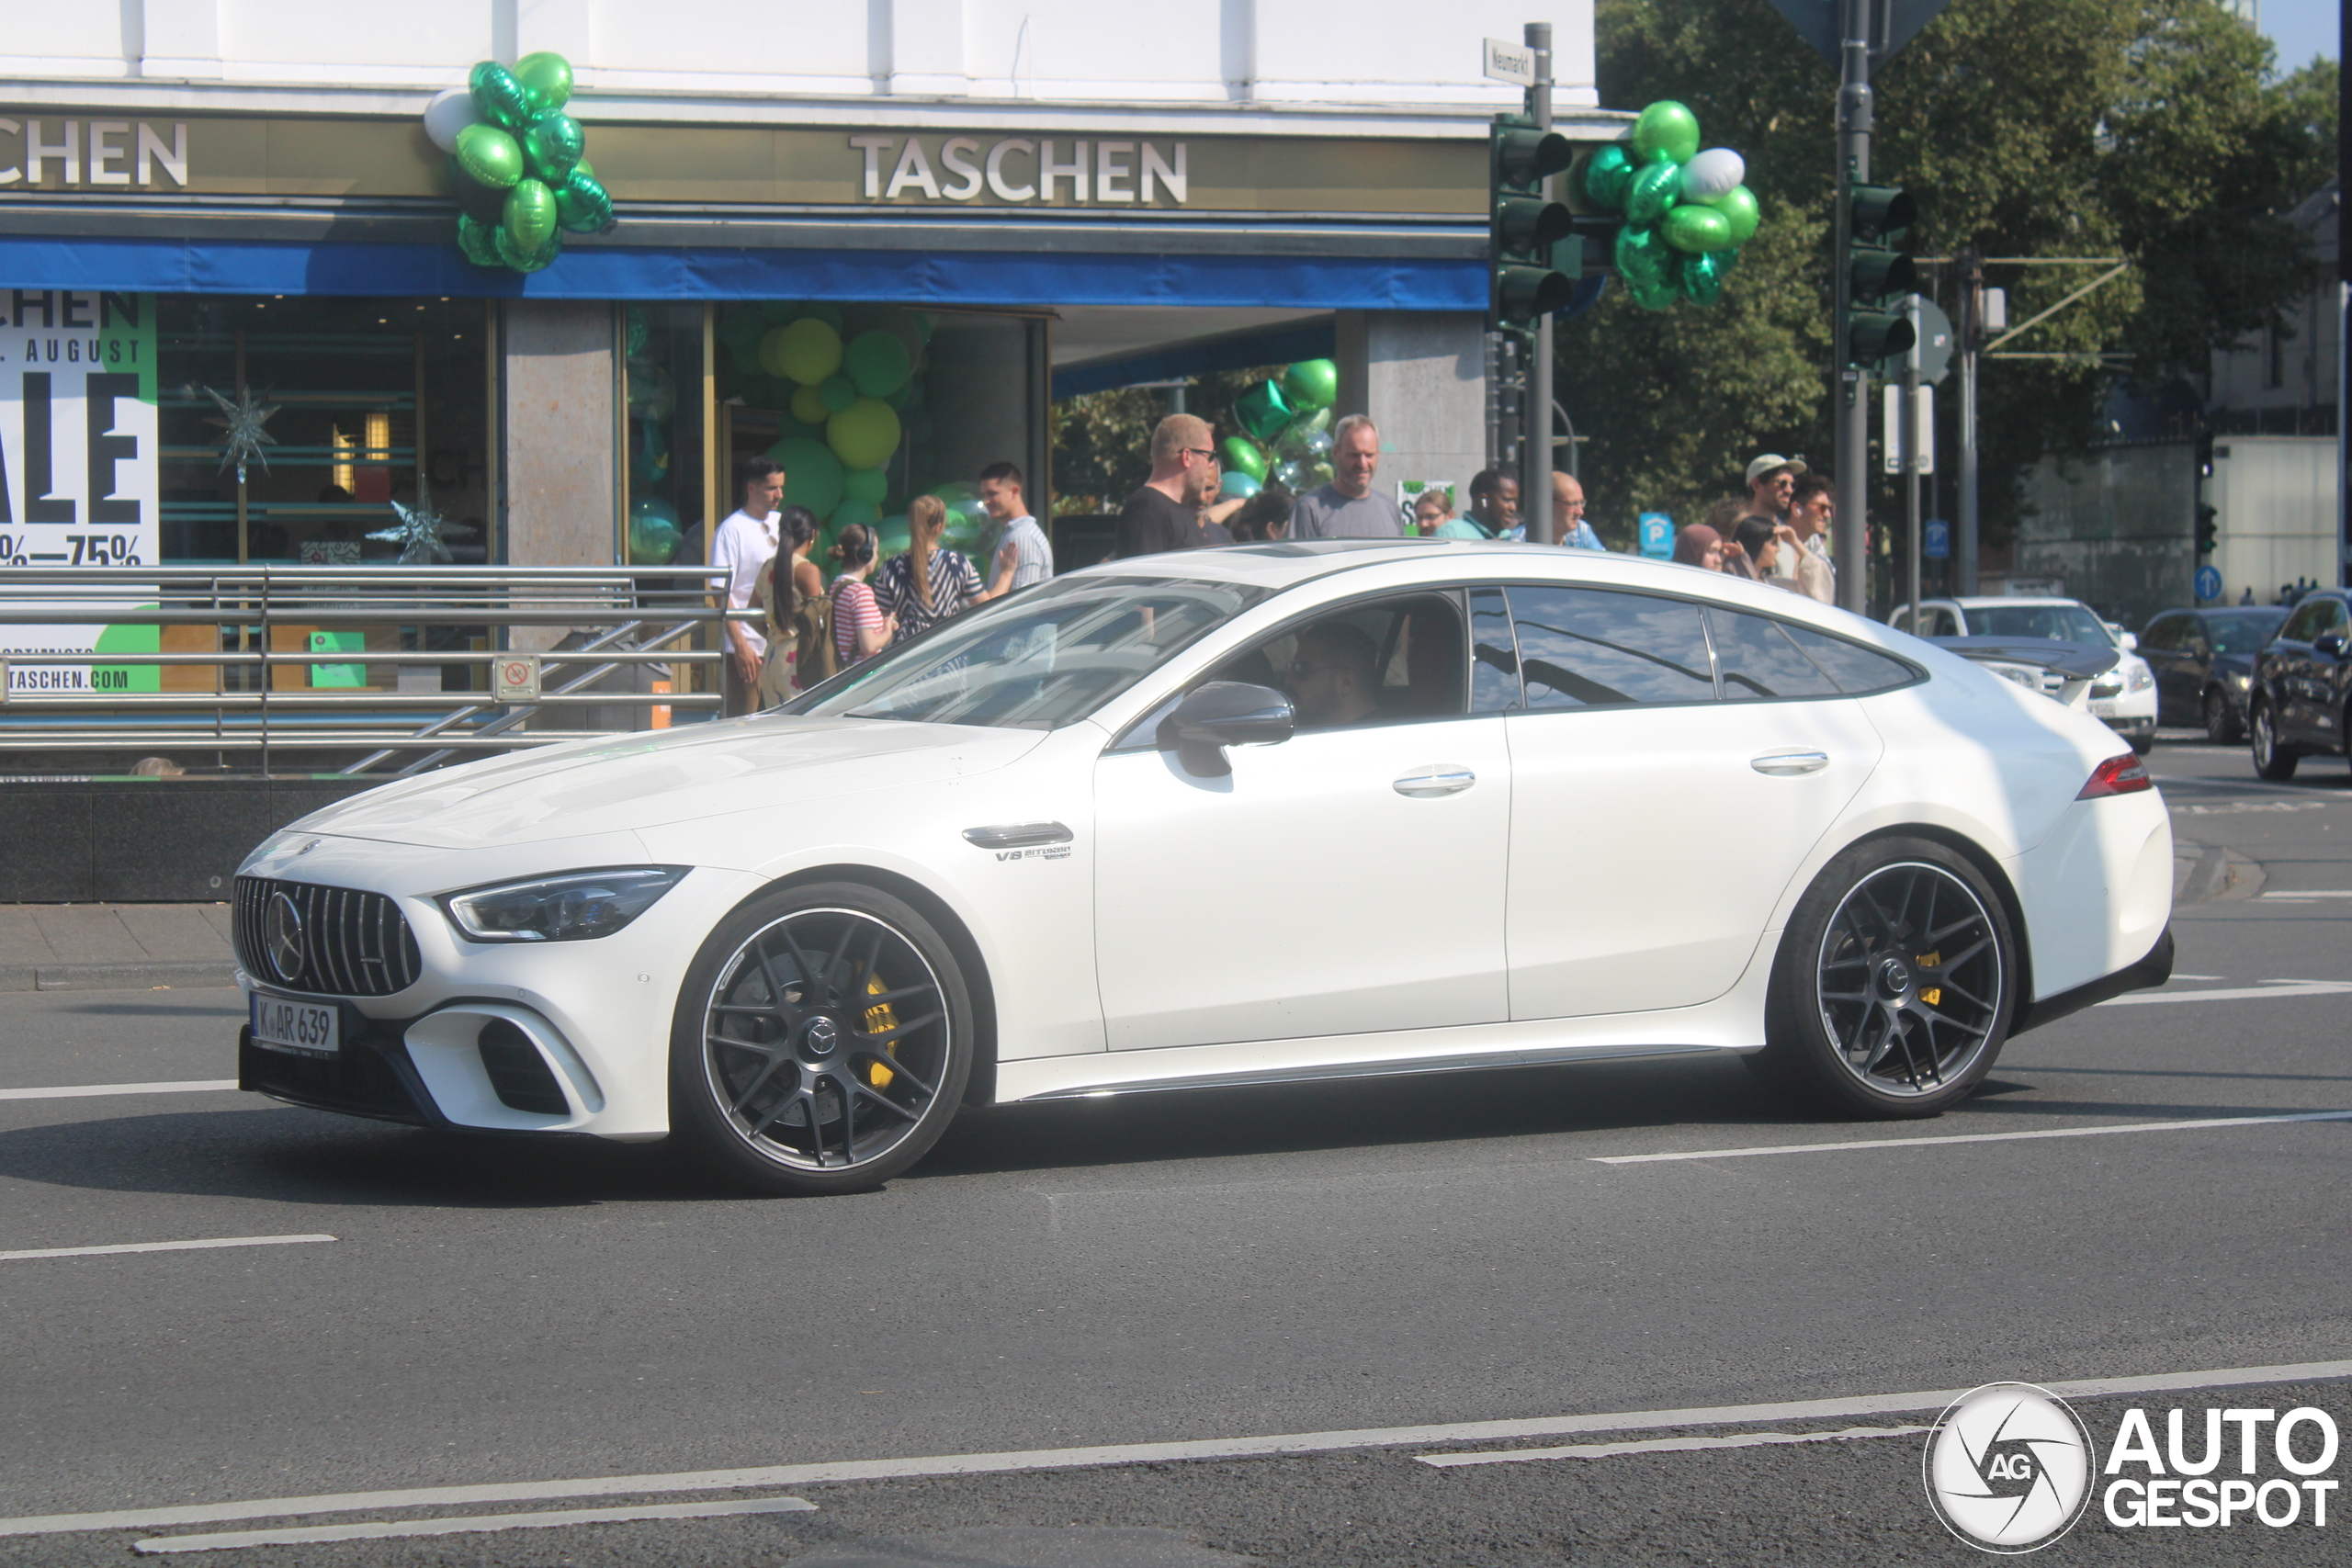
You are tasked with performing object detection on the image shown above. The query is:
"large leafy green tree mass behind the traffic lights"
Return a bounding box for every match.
[1562,0,2335,552]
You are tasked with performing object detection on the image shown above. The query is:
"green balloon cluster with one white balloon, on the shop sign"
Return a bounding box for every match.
[425,51,612,273]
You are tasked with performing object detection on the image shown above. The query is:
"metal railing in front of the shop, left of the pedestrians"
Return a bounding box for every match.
[0,567,760,773]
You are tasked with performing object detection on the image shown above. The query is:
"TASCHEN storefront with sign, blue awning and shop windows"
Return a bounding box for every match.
[0,104,1618,582]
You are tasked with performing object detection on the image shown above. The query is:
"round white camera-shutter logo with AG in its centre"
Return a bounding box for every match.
[1922,1382,2093,1554]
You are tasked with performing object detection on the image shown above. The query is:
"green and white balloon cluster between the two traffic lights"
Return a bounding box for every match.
[1576,98,1759,310]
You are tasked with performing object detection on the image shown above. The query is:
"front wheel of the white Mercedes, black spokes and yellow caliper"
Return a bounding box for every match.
[671,882,974,1197]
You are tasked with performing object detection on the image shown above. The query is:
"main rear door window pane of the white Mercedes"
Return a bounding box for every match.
[1508,583,1714,710]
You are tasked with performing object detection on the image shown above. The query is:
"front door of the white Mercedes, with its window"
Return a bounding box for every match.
[1093,592,1510,1051]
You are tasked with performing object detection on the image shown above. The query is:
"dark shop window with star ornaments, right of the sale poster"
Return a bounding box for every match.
[155,294,496,567]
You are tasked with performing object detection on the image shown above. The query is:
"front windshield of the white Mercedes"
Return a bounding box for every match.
[783,576,1272,728]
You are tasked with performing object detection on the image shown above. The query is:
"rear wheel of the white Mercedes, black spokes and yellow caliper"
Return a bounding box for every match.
[1747,837,2018,1119]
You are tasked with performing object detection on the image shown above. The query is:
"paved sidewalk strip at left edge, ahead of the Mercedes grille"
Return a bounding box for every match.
[0,903,238,992]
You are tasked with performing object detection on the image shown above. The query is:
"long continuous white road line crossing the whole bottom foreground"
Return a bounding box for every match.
[0,1361,2352,1538]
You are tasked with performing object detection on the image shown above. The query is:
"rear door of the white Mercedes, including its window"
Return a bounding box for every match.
[1473,585,1910,1018]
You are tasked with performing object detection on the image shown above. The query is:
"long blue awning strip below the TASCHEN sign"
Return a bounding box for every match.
[0,237,1487,310]
